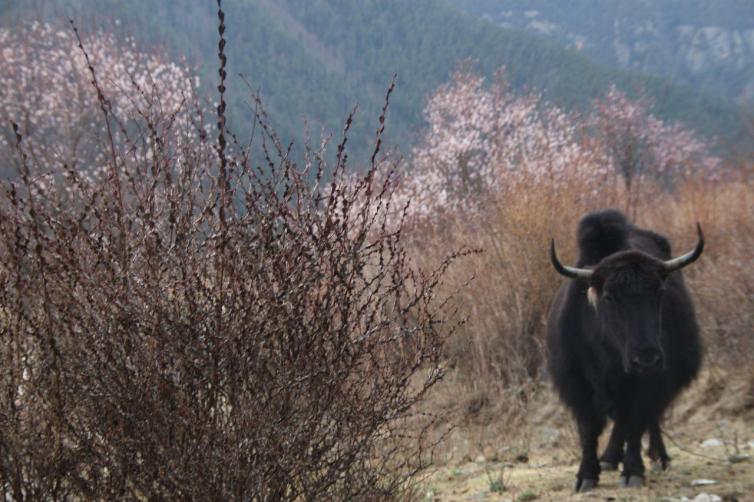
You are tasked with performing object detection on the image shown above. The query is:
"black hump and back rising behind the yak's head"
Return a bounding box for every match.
[576,209,672,268]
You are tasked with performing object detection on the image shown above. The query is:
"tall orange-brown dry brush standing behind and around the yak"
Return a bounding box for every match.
[408,166,754,466]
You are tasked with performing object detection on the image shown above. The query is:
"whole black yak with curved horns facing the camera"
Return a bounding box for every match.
[547,210,704,491]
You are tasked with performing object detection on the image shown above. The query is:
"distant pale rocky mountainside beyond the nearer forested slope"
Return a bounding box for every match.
[452,0,754,101]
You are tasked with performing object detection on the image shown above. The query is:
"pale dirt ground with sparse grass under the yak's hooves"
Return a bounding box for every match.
[419,368,754,502]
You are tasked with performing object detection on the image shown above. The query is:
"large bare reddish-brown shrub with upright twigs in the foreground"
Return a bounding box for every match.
[0,4,457,500]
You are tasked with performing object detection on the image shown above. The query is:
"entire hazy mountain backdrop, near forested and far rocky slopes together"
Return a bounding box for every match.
[0,0,754,163]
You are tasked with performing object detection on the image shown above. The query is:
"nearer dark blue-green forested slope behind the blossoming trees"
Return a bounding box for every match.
[0,0,743,158]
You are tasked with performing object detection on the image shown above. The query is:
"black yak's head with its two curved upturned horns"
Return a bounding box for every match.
[550,224,704,375]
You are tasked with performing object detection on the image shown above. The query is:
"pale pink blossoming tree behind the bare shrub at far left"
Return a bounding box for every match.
[0,22,198,187]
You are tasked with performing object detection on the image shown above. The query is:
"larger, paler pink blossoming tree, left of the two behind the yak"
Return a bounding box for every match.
[401,69,604,214]
